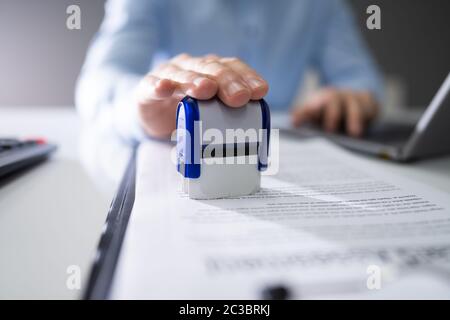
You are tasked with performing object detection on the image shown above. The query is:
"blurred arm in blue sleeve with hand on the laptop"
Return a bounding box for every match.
[293,0,383,136]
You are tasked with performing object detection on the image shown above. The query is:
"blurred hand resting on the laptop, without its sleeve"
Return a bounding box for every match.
[292,88,379,137]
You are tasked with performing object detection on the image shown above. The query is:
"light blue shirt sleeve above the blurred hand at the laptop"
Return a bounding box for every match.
[315,0,384,102]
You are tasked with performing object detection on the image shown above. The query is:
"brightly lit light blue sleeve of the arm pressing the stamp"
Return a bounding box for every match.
[75,0,159,141]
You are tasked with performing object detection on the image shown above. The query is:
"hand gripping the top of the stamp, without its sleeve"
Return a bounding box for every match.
[135,54,269,138]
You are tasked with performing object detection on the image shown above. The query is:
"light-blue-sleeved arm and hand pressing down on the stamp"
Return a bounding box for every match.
[77,0,268,141]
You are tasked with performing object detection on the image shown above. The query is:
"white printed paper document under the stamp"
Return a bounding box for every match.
[111,138,450,299]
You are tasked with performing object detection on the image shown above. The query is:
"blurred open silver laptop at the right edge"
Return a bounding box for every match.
[280,73,450,162]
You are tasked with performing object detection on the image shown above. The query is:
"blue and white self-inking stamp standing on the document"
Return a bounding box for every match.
[177,96,270,199]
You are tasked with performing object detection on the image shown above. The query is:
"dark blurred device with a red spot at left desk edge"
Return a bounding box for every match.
[0,138,56,179]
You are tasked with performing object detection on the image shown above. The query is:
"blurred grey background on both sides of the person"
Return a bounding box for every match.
[0,0,450,107]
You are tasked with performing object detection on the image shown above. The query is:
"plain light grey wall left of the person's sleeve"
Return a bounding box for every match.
[0,0,104,106]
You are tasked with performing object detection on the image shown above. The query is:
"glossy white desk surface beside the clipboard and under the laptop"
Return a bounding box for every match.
[0,107,450,299]
